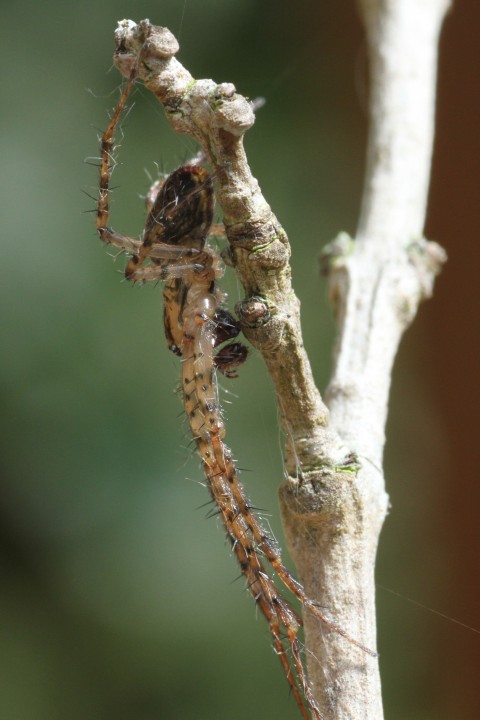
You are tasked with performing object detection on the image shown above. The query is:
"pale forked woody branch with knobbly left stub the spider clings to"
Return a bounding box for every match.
[109,0,448,720]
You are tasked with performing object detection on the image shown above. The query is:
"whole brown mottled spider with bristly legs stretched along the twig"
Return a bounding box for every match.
[97,71,374,720]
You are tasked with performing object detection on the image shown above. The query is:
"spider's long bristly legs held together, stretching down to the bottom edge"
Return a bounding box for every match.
[180,268,321,720]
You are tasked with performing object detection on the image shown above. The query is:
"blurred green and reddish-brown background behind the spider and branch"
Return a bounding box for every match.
[0,0,480,720]
